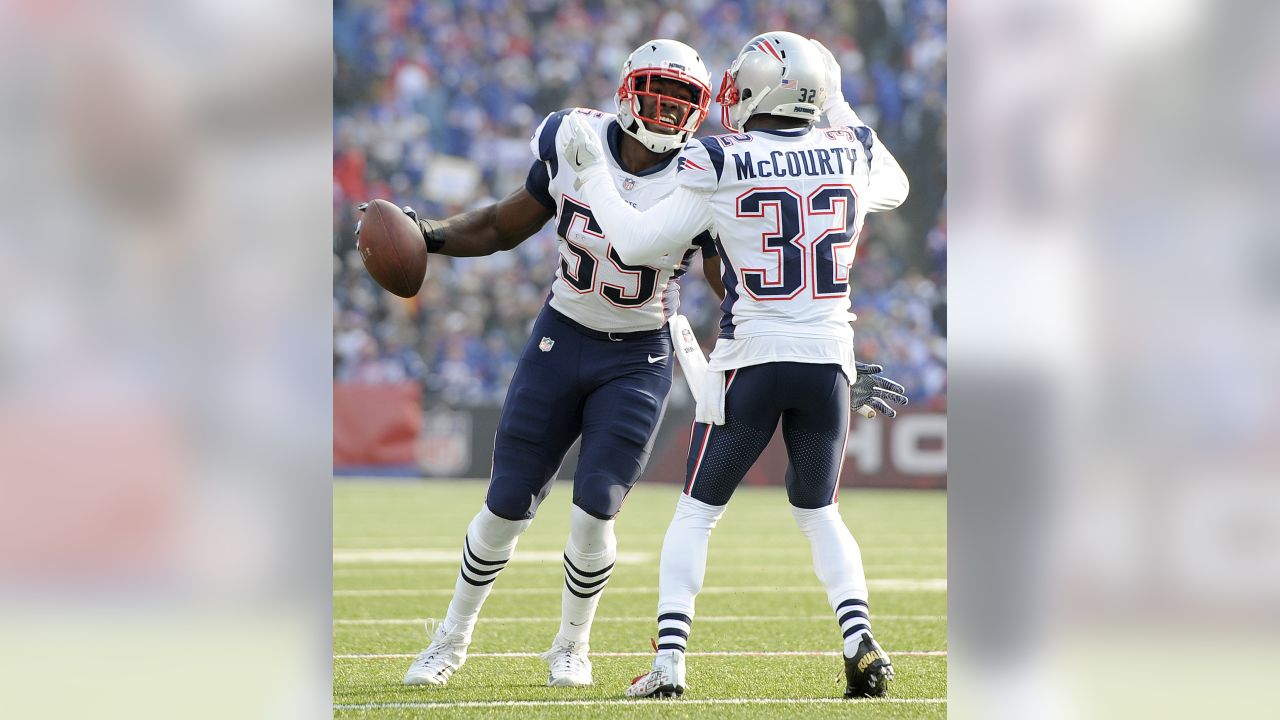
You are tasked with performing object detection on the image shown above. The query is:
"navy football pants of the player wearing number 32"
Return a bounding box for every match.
[685,363,849,510]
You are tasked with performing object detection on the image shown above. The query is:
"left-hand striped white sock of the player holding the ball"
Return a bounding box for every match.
[444,506,532,642]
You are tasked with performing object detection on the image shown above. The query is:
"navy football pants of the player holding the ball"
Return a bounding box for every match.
[485,306,675,520]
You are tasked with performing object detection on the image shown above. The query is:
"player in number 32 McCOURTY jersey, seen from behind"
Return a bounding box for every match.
[563,32,908,697]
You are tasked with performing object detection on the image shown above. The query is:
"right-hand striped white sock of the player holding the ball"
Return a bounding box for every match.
[559,505,618,643]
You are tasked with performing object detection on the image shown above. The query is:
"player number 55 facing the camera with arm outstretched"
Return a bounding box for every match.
[371,40,723,687]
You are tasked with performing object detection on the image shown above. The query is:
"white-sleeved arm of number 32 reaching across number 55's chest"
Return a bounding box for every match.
[558,115,712,265]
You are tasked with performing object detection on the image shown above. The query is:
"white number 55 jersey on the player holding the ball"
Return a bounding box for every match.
[525,108,716,332]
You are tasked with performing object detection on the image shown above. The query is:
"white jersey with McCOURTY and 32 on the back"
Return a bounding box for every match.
[676,126,906,378]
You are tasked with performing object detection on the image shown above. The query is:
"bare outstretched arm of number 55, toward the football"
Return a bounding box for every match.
[417,187,556,258]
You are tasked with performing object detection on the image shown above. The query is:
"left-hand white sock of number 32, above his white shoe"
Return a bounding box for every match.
[658,495,724,652]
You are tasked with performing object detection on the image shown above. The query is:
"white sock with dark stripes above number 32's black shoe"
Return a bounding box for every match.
[791,505,870,656]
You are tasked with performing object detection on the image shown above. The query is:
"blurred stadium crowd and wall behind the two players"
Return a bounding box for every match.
[333,0,947,487]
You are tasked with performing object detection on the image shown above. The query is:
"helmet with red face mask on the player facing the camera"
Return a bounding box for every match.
[614,40,712,152]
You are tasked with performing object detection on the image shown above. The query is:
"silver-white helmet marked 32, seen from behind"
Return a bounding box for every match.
[716,31,829,132]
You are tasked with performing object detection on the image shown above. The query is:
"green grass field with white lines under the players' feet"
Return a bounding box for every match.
[333,480,947,719]
